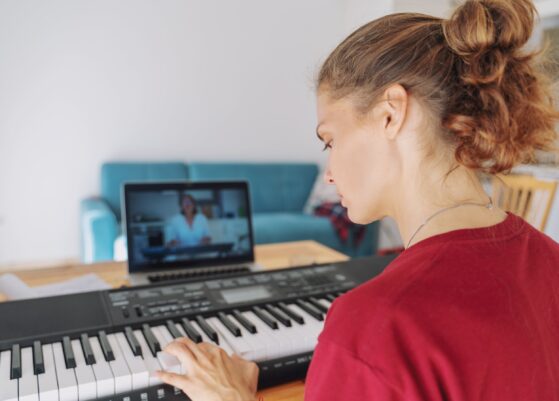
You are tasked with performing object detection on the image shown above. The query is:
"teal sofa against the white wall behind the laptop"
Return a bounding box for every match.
[80,162,378,263]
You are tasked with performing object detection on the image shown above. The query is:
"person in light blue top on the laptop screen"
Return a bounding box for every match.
[165,193,211,248]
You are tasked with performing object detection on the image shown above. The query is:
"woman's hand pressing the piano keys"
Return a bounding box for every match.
[157,338,258,401]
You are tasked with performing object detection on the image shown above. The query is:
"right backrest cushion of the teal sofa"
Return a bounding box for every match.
[188,163,318,213]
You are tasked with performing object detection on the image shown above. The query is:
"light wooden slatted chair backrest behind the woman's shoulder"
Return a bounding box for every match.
[492,175,557,231]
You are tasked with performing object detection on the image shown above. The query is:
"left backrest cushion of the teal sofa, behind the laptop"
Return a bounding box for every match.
[101,162,188,221]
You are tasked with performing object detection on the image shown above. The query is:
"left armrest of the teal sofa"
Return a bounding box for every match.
[80,198,118,263]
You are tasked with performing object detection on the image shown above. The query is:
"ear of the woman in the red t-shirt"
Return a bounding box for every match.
[379,84,408,139]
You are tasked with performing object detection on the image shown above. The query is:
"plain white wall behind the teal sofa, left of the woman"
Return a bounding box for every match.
[0,0,364,264]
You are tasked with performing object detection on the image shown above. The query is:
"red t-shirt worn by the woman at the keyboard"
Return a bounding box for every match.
[305,213,559,401]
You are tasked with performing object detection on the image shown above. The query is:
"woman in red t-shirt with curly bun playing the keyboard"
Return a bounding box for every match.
[155,0,559,401]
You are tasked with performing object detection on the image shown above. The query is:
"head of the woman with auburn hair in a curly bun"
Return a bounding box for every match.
[317,0,559,223]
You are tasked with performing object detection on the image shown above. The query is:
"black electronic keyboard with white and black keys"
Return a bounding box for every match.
[0,255,394,401]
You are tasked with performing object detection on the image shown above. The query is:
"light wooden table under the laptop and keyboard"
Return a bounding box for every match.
[0,241,349,401]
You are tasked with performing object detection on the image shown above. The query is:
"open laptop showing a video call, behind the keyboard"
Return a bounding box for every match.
[123,181,261,285]
